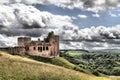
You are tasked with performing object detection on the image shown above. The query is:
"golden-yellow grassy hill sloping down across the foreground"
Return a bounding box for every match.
[0,51,110,80]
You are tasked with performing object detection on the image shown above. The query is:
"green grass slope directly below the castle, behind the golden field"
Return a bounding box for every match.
[26,55,75,69]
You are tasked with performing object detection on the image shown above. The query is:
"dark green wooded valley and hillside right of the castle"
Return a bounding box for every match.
[61,50,120,76]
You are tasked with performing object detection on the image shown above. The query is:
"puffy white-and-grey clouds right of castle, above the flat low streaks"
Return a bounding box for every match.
[62,25,120,42]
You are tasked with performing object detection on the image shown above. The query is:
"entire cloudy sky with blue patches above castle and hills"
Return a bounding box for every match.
[0,0,120,50]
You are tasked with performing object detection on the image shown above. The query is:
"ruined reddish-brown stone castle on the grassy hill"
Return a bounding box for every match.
[8,32,59,57]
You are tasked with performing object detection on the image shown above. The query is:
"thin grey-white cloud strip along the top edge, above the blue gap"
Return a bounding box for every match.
[0,0,120,12]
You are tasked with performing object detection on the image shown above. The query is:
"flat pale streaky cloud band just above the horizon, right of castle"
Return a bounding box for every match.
[60,40,120,50]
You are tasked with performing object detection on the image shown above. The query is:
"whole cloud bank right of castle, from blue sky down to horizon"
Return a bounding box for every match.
[57,25,120,50]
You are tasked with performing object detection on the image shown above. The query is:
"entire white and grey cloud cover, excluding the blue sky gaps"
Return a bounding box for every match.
[0,0,120,49]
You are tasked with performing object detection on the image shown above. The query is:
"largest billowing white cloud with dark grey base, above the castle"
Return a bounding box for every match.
[0,4,78,36]
